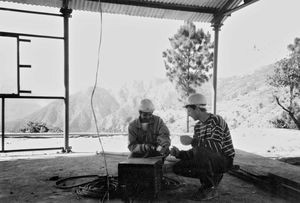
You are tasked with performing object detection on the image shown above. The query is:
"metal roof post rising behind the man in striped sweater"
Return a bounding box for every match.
[212,23,222,114]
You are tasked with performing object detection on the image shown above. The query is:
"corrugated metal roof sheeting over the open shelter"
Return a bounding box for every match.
[0,0,251,22]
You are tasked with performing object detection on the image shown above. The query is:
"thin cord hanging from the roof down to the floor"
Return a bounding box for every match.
[91,0,110,202]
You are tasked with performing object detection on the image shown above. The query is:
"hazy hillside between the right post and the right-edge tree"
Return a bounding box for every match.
[217,65,282,128]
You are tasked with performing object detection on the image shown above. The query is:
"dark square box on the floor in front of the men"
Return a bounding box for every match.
[118,158,163,198]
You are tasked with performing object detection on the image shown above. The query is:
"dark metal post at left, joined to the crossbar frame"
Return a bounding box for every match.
[60,7,72,152]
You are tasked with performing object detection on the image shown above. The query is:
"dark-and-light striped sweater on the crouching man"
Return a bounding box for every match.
[193,114,235,158]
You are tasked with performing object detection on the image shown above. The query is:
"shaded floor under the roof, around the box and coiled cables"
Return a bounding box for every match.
[0,153,288,203]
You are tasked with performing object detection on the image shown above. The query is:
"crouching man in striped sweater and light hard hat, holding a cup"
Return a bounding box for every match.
[170,93,235,200]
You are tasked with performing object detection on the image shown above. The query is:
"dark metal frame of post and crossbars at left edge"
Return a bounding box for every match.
[0,5,72,152]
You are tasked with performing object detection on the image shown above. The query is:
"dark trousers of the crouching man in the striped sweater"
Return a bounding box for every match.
[173,147,233,187]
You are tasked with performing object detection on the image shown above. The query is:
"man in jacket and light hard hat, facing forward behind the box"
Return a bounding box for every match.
[128,99,171,158]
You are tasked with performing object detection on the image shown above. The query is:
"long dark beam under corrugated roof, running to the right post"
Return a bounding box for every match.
[87,0,218,14]
